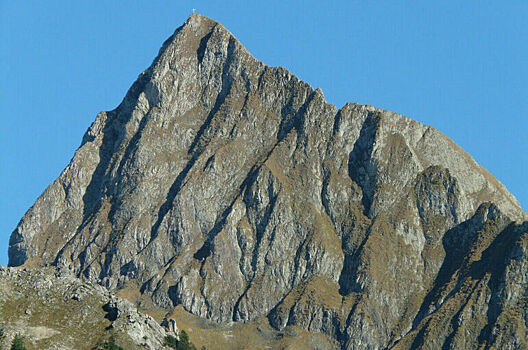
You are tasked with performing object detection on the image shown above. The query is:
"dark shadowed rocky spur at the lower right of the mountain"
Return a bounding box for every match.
[394,209,528,349]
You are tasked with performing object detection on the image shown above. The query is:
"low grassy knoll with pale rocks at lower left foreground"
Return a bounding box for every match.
[0,266,171,350]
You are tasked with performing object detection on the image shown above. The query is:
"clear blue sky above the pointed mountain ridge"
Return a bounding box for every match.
[0,0,528,264]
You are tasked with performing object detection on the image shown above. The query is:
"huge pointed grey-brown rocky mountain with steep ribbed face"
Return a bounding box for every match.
[9,14,528,349]
